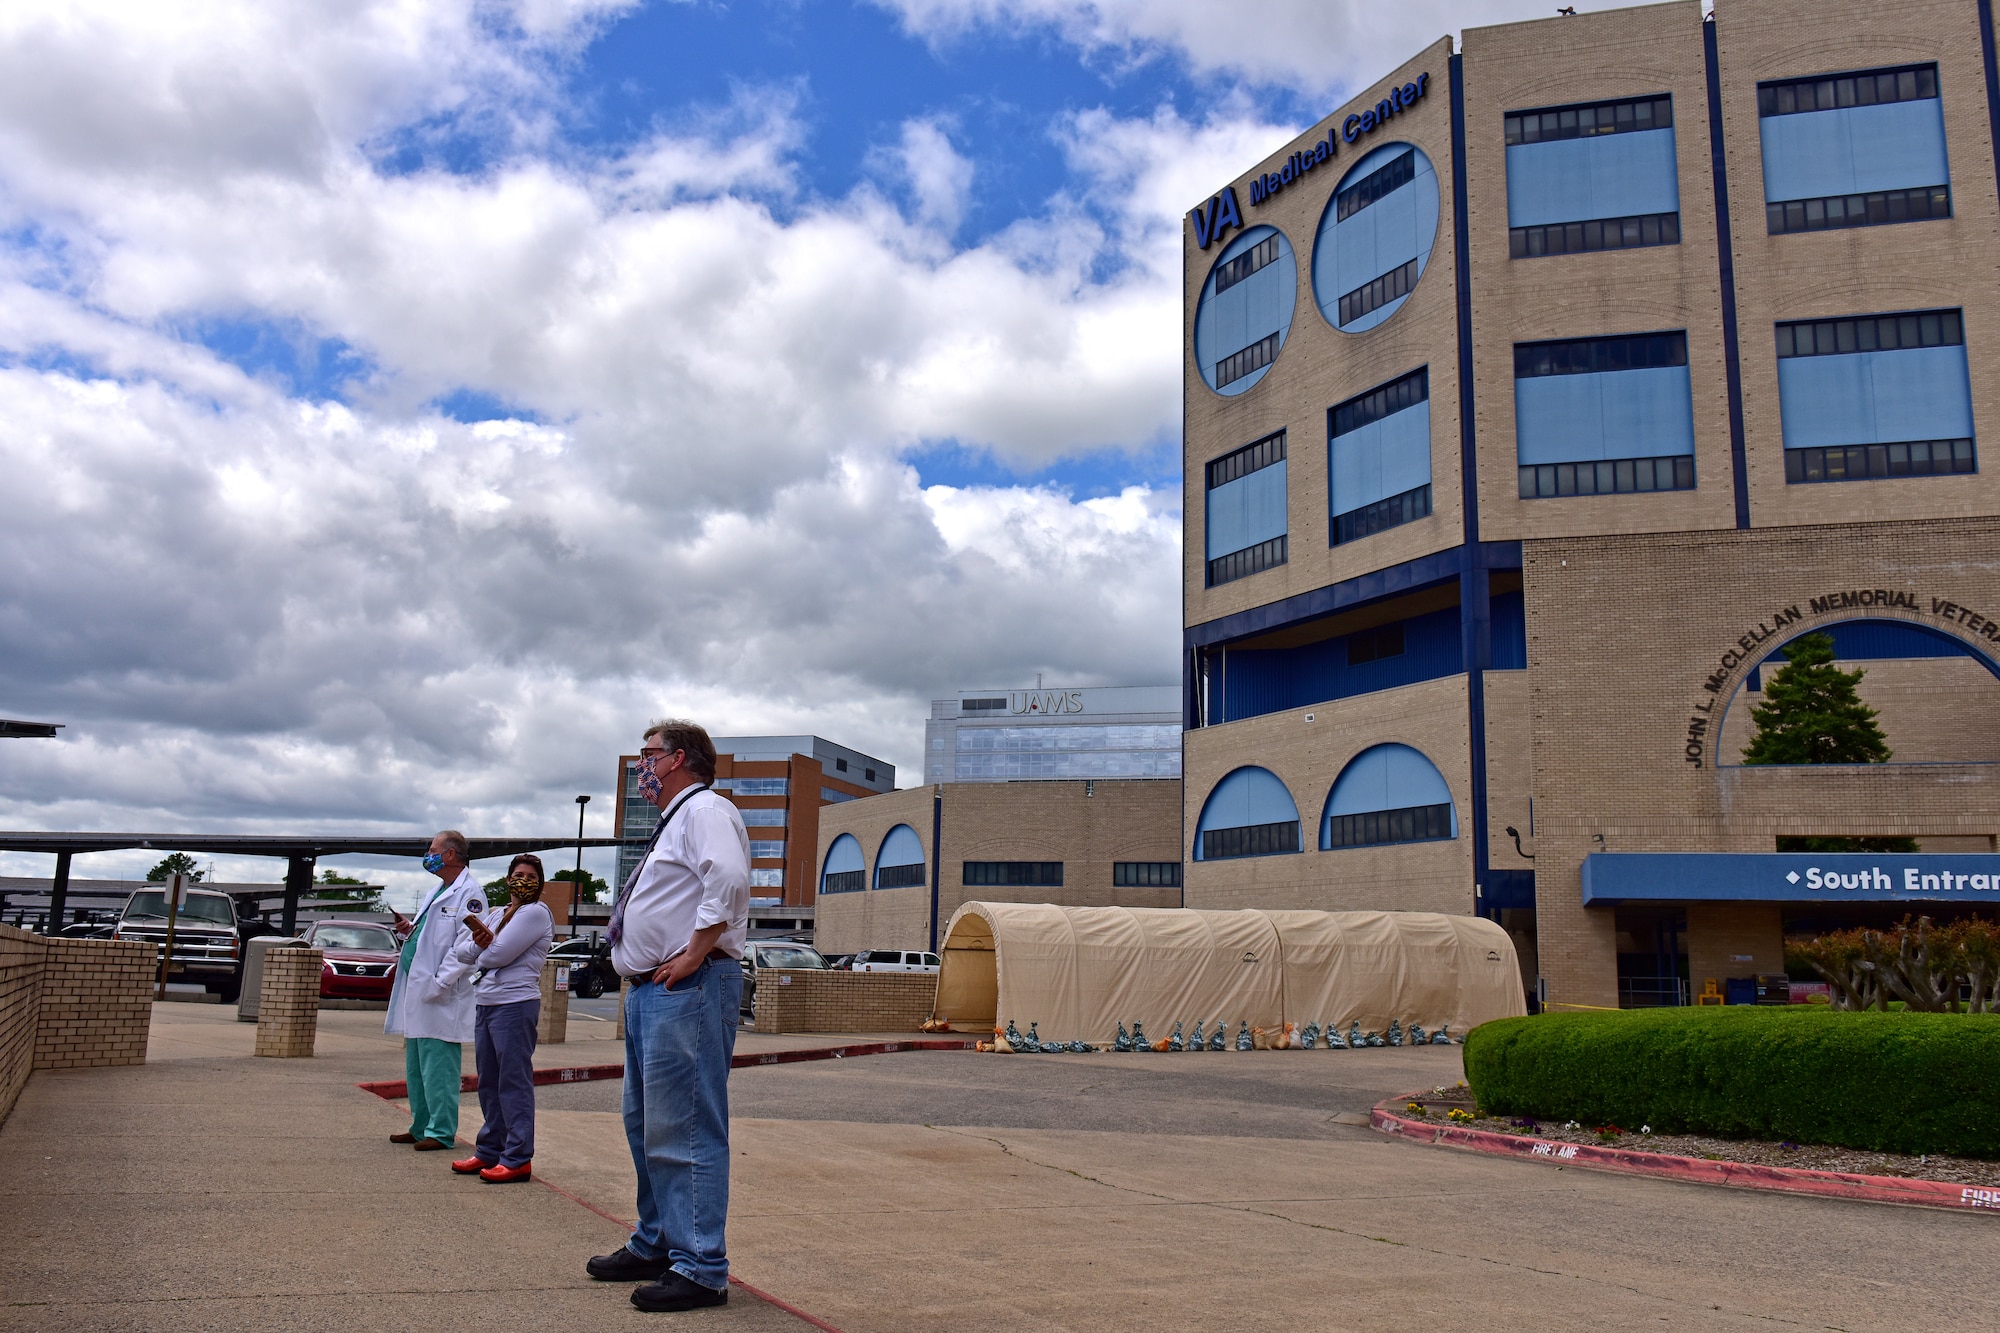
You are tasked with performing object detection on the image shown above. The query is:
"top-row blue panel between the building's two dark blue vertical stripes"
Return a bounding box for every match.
[1506,128,1680,226]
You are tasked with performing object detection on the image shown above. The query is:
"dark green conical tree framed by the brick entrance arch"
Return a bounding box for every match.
[1744,634,1916,853]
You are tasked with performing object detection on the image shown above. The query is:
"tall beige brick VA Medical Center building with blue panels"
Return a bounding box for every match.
[1184,0,2000,1005]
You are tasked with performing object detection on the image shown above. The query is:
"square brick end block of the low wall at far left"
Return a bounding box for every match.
[34,939,158,1069]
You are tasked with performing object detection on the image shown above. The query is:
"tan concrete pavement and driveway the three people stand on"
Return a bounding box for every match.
[0,1005,2000,1333]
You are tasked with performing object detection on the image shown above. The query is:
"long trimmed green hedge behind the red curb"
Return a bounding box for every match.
[1464,1005,2000,1157]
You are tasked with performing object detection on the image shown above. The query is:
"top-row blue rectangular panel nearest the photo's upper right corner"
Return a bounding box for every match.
[1758,98,1952,202]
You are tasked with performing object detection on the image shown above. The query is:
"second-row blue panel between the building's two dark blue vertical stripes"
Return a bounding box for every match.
[1514,366,1694,464]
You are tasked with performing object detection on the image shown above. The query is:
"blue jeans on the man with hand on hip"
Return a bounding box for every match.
[624,959,744,1289]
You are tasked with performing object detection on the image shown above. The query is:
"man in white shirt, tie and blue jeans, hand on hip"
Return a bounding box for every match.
[584,719,750,1311]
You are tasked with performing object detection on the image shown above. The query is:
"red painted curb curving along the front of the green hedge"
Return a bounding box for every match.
[1368,1097,2000,1213]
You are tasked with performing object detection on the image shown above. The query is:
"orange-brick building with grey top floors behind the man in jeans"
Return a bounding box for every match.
[614,737,896,907]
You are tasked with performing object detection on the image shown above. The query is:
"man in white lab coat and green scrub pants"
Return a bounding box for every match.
[382,829,486,1153]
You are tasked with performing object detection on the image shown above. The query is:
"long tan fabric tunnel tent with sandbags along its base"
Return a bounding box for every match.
[934,903,1526,1045]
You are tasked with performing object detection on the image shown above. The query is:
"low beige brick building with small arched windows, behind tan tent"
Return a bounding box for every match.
[814,779,1182,953]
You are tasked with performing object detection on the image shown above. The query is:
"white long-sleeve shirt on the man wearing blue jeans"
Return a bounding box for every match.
[612,791,750,977]
